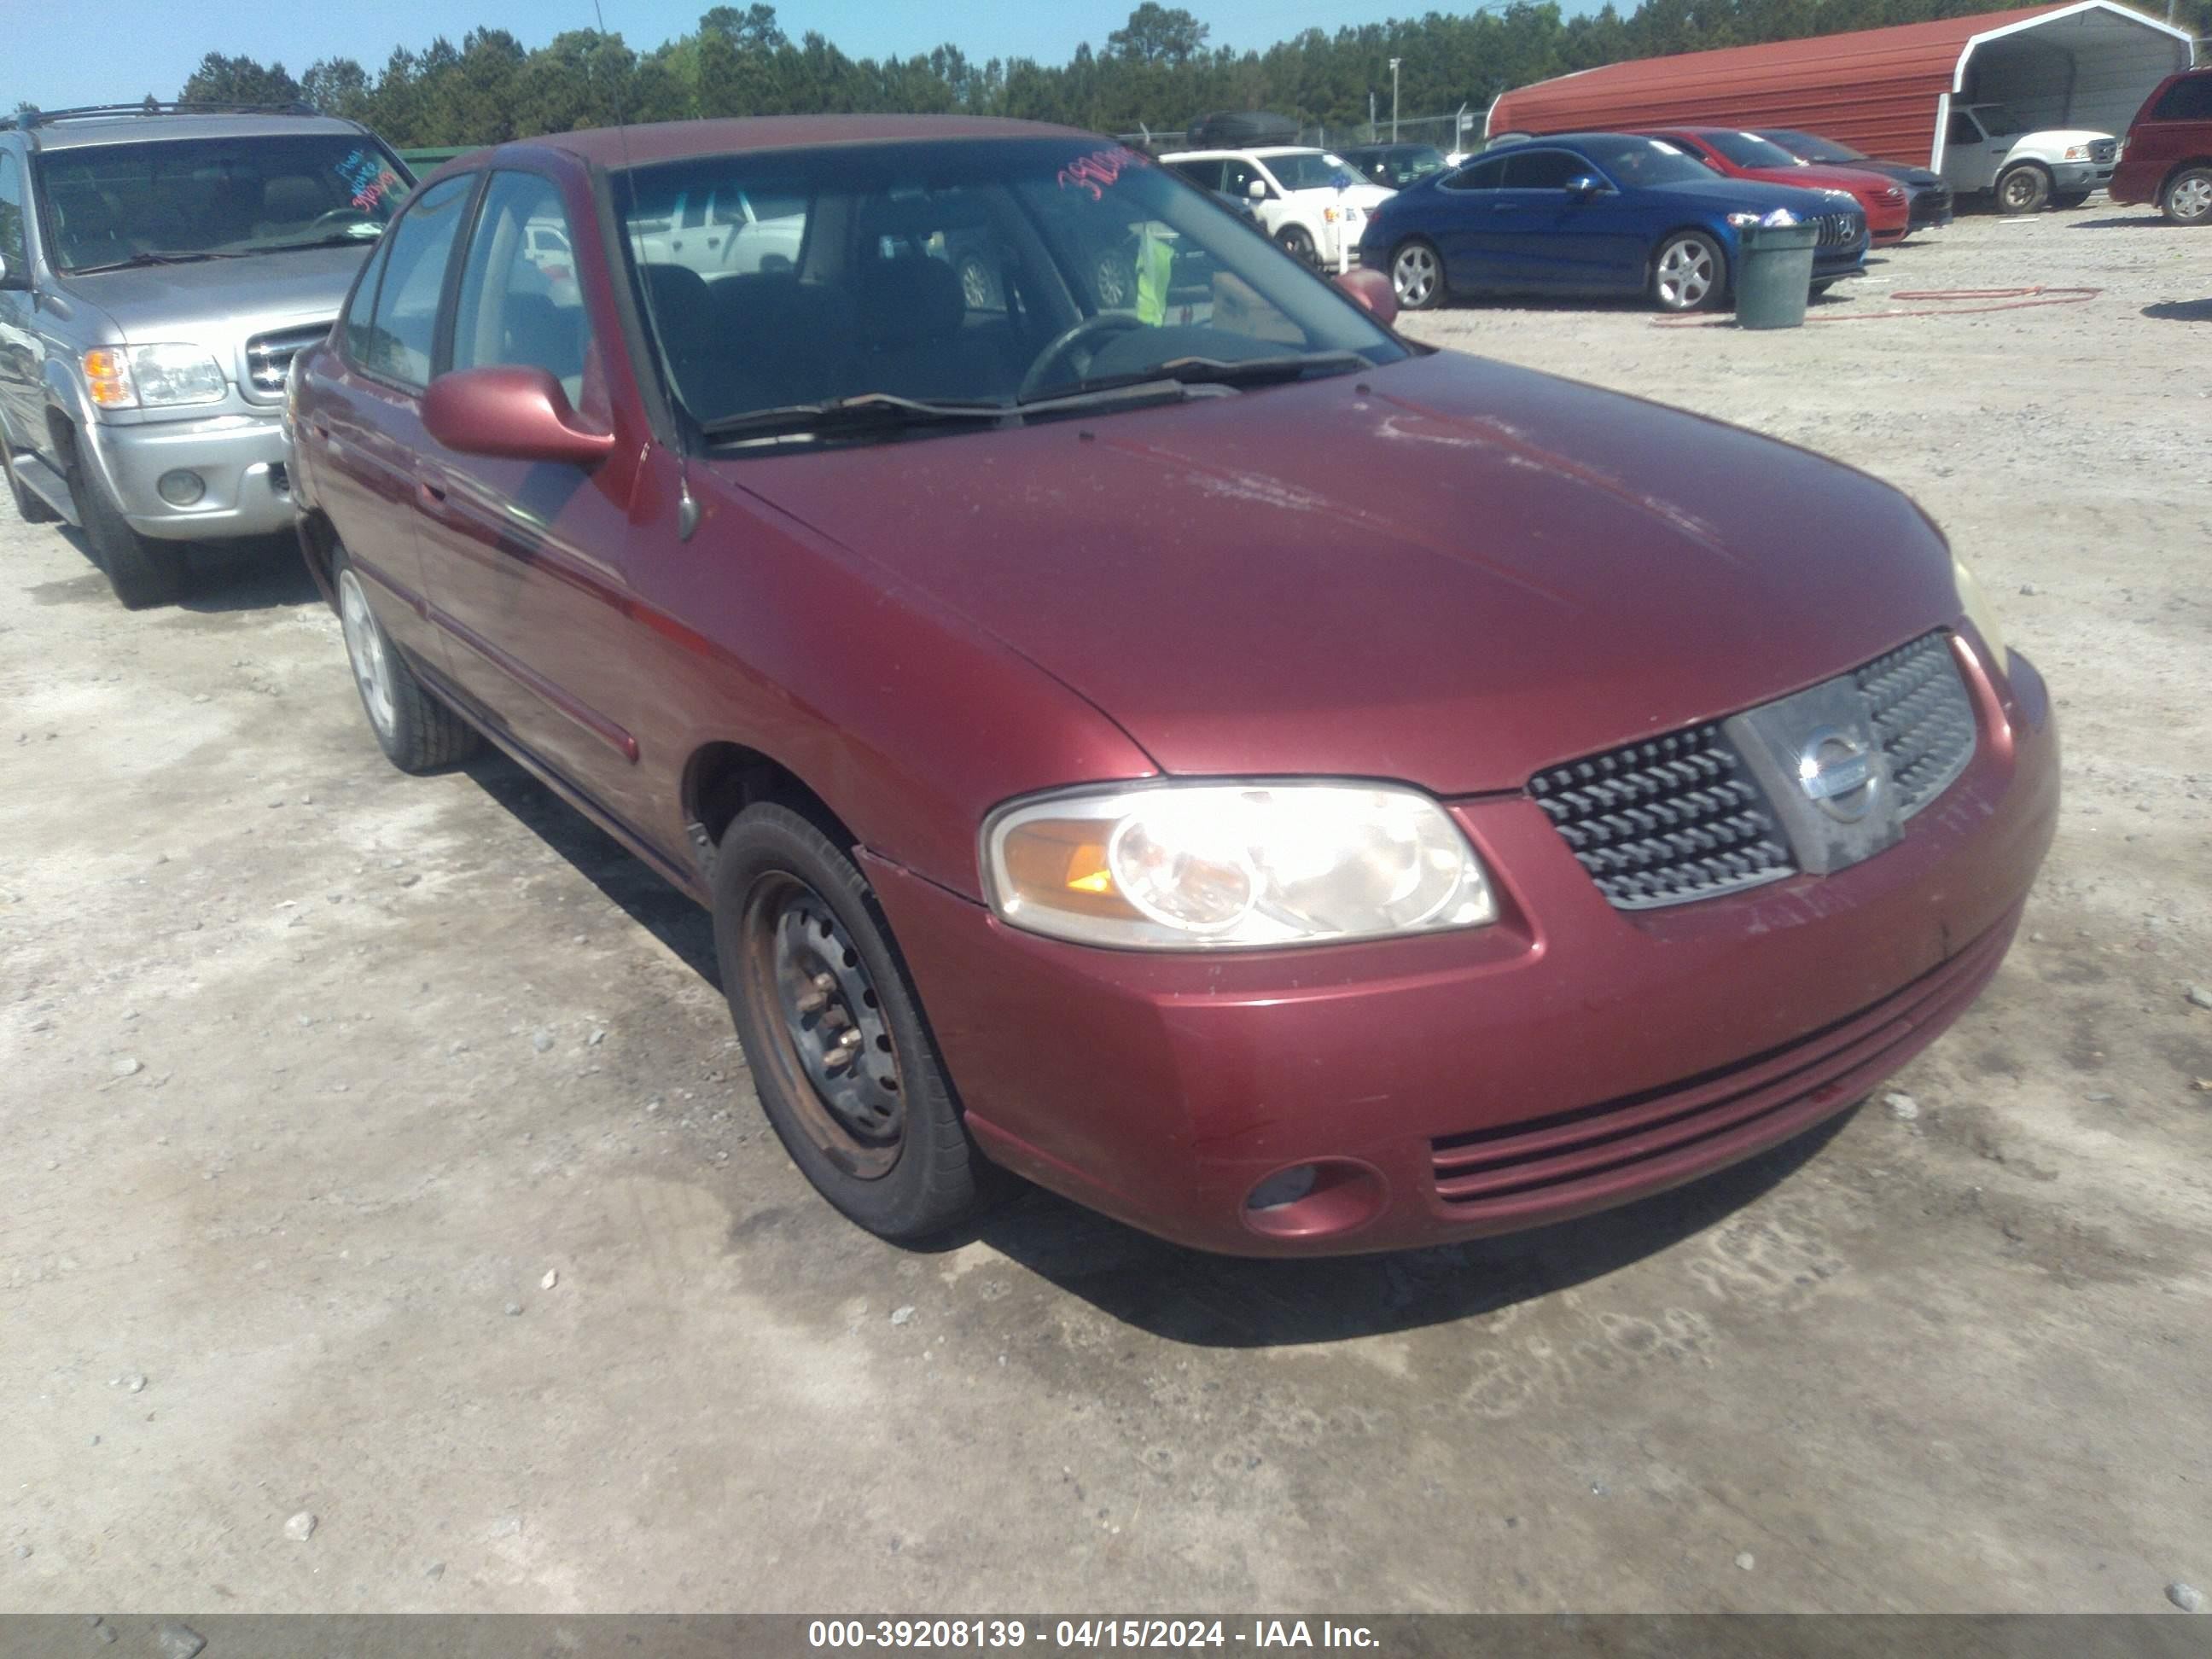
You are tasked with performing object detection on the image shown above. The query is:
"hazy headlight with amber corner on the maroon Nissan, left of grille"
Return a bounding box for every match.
[982,783,1498,952]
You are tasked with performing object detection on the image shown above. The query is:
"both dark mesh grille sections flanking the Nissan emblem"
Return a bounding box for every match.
[1528,631,1976,909]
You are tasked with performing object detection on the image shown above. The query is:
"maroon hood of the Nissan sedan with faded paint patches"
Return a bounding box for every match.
[734,352,1958,795]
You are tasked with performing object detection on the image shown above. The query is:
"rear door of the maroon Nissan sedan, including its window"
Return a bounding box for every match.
[299,172,480,672]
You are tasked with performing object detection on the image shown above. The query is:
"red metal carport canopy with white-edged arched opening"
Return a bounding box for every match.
[1484,0,2194,166]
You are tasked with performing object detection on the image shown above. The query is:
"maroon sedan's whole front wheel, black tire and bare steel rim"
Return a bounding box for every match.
[714,800,1004,1243]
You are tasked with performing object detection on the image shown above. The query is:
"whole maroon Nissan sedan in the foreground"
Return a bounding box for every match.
[290,117,2058,1254]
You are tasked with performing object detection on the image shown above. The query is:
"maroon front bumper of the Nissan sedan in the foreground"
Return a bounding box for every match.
[867,641,2059,1254]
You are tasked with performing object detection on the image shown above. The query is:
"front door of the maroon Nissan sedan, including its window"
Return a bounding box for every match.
[418,171,648,832]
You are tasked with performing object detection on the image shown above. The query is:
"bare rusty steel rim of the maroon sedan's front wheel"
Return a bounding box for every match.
[743,871,907,1181]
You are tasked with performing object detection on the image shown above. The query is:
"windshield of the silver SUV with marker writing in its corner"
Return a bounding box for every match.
[38,133,407,272]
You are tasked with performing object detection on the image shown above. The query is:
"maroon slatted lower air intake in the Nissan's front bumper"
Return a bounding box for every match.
[1429,911,2019,1225]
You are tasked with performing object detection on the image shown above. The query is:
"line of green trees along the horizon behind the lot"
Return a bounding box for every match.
[9,0,2212,146]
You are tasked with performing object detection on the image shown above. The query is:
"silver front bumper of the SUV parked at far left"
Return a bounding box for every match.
[90,410,292,542]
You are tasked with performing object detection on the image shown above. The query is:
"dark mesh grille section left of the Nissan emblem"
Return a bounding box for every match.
[1528,725,1796,909]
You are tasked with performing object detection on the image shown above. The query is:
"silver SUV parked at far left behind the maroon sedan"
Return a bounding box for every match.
[0,104,414,608]
